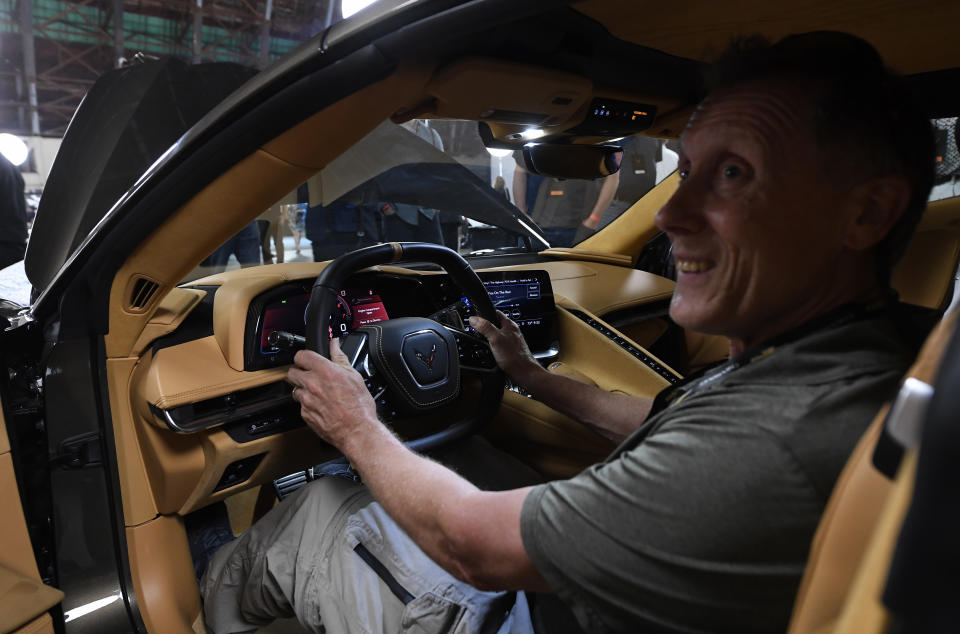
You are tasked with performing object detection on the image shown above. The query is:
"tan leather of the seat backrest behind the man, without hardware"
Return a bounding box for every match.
[788,313,957,634]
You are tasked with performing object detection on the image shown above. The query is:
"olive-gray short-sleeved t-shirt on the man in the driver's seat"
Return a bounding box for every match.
[521,318,913,632]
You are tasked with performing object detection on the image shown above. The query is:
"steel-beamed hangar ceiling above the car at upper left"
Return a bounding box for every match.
[0,0,330,136]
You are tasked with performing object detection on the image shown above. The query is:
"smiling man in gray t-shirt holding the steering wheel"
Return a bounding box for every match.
[202,33,934,632]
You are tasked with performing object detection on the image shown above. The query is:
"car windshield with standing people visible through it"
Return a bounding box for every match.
[188,119,677,279]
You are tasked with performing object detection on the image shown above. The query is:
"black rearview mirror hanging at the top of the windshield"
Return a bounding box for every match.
[523,143,623,179]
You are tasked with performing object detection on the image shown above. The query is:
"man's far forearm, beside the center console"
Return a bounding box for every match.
[514,366,653,442]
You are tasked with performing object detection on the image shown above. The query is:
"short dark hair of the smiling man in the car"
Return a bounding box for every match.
[707,31,936,285]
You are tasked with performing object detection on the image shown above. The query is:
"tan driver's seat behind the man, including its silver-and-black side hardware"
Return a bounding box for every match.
[788,304,960,634]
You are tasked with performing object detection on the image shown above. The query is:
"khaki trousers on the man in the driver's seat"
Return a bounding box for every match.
[201,440,533,634]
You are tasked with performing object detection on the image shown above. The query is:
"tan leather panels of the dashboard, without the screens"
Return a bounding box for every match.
[120,261,673,525]
